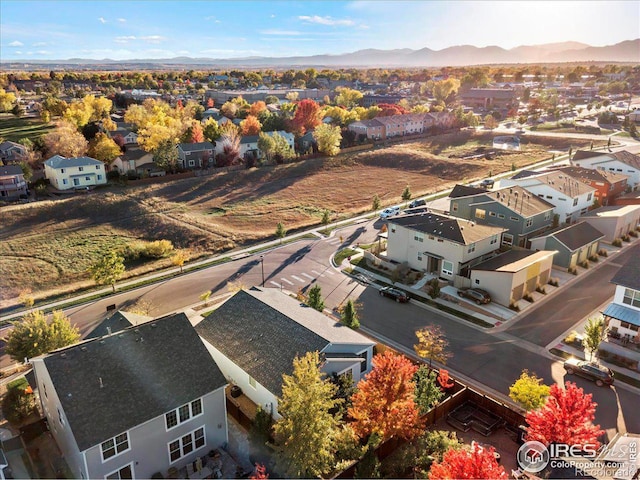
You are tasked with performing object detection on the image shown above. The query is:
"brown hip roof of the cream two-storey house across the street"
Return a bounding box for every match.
[388,212,506,245]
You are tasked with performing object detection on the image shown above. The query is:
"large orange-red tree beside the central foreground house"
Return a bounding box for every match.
[349,351,422,440]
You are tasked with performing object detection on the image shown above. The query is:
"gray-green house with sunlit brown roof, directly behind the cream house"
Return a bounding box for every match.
[449,185,554,247]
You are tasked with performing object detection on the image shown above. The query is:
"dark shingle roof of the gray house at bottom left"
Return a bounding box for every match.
[44,313,227,451]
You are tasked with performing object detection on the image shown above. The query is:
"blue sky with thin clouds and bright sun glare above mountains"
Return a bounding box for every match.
[0,0,640,62]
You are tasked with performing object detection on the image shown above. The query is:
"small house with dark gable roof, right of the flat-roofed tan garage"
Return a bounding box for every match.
[529,221,604,268]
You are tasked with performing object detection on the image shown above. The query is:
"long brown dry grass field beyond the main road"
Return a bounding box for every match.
[0,132,600,308]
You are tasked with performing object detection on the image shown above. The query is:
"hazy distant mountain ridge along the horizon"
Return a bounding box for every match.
[1,38,640,67]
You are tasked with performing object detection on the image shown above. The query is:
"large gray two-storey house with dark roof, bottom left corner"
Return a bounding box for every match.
[31,314,228,478]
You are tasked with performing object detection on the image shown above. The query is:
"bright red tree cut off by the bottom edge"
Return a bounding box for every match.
[429,444,508,480]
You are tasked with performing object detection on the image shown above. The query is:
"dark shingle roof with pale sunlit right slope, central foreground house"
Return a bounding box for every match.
[196,287,373,396]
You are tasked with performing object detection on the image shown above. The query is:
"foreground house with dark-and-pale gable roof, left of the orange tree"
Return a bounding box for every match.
[195,287,374,418]
